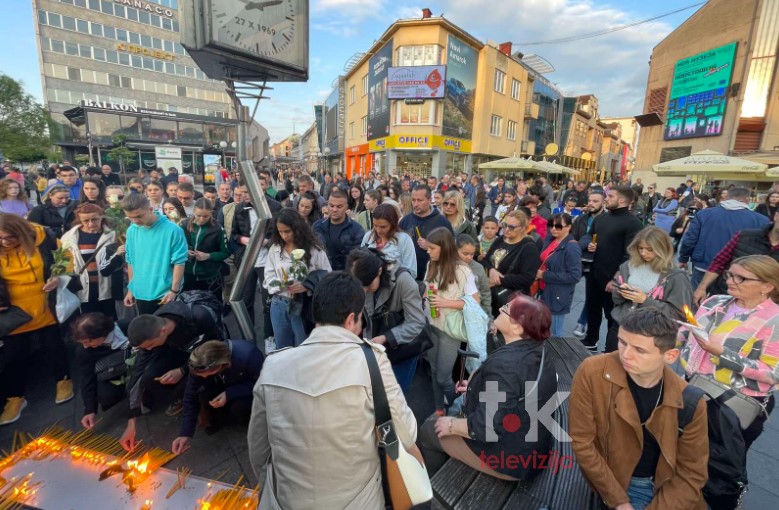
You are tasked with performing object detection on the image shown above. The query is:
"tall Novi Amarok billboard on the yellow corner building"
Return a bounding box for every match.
[442,35,479,139]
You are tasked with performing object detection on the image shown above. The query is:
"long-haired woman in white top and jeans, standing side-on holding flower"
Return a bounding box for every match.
[424,227,479,416]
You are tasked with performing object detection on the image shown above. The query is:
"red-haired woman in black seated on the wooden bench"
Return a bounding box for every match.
[419,295,557,481]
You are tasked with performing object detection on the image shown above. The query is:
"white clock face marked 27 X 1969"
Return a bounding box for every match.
[211,0,300,60]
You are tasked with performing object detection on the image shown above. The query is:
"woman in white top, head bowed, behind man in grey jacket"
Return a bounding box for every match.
[361,204,417,278]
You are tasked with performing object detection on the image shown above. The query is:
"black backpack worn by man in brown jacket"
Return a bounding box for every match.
[679,384,748,509]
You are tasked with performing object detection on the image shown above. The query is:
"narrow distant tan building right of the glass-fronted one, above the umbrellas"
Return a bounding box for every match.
[561,94,606,180]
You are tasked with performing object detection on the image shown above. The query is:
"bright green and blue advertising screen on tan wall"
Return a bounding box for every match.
[664,42,737,140]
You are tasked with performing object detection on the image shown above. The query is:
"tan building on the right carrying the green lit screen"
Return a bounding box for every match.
[634,0,779,187]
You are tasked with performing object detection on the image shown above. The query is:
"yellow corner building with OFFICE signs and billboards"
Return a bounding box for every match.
[342,10,538,176]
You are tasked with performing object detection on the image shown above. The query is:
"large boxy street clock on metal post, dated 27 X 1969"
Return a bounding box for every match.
[181,0,308,81]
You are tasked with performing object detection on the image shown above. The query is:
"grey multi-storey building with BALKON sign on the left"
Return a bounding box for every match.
[33,0,267,171]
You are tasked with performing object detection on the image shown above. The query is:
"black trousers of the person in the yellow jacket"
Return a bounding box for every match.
[0,324,70,403]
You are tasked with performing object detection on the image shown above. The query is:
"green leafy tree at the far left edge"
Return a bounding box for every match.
[0,74,51,162]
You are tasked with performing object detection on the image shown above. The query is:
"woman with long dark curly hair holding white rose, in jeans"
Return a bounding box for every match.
[263,208,332,349]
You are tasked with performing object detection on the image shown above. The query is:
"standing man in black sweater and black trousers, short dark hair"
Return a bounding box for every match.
[582,186,643,352]
